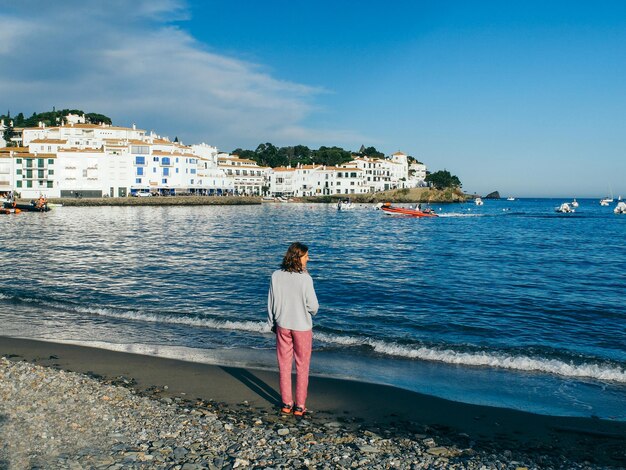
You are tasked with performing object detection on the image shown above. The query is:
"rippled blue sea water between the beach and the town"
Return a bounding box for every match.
[0,199,626,420]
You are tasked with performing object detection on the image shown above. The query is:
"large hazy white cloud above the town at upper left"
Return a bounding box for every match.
[0,0,363,150]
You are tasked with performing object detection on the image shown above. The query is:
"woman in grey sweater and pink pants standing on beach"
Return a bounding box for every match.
[267,242,319,416]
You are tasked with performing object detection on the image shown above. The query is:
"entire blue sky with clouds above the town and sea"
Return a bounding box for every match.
[0,0,626,198]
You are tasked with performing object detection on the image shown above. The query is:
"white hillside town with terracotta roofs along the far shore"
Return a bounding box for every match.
[0,114,426,199]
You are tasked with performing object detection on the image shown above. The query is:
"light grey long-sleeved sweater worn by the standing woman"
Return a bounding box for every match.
[267,270,319,331]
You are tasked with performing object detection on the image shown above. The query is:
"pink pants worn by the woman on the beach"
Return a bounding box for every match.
[276,326,313,407]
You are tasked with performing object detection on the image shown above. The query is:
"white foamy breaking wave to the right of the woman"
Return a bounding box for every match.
[315,333,626,383]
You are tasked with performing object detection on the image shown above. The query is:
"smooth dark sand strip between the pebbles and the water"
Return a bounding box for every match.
[0,336,626,468]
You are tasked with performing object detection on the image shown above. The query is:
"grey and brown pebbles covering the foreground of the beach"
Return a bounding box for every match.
[0,357,618,470]
